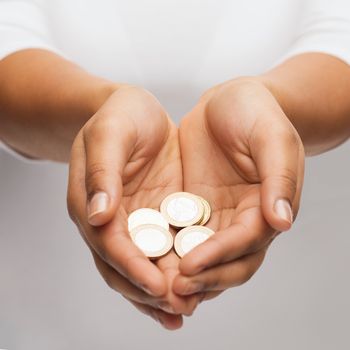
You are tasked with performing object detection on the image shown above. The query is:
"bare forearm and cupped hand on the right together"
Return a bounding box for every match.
[173,54,350,299]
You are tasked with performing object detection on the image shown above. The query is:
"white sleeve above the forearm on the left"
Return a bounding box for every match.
[0,0,61,60]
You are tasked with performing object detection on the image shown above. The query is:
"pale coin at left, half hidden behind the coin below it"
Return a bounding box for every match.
[128,208,169,232]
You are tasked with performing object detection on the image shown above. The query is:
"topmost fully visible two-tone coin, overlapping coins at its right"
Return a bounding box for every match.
[160,192,204,228]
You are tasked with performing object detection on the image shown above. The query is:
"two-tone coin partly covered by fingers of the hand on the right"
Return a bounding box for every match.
[174,225,214,258]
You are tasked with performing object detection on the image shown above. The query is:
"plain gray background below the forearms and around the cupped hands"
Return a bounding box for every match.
[0,110,350,350]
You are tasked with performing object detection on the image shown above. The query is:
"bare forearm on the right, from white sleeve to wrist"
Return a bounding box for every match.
[259,53,350,154]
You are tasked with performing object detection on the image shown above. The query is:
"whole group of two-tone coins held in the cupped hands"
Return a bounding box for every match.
[128,192,214,259]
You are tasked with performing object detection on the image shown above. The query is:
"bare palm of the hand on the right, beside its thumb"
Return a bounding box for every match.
[180,100,268,247]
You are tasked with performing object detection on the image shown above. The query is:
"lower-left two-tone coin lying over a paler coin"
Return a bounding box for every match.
[130,224,174,259]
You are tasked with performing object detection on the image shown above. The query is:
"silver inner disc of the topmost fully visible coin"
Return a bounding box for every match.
[167,197,199,222]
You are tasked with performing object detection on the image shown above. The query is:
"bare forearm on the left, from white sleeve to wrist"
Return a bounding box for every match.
[0,49,118,161]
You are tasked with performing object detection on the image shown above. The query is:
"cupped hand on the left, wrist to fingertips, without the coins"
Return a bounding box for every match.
[67,86,198,329]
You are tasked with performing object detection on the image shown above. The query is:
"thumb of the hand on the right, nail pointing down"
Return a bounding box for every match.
[250,117,304,231]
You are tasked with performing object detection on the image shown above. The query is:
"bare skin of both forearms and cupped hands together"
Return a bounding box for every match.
[0,49,350,329]
